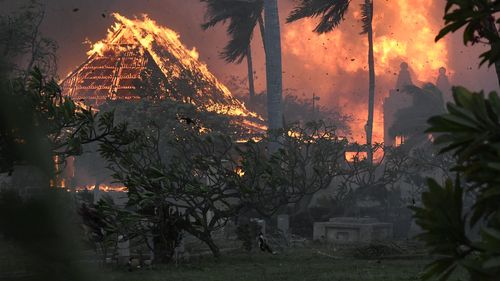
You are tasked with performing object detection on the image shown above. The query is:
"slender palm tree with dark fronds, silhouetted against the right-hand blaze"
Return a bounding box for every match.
[287,0,375,163]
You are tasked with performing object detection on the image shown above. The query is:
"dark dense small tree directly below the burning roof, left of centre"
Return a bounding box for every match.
[100,119,242,256]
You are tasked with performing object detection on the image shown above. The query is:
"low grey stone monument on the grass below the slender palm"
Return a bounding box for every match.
[313,217,393,243]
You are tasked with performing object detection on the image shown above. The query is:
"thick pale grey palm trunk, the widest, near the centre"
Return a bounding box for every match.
[264,0,283,141]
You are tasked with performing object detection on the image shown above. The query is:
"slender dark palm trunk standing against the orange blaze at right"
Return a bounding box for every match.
[366,0,375,163]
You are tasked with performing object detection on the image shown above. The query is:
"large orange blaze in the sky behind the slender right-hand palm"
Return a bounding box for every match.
[283,0,450,142]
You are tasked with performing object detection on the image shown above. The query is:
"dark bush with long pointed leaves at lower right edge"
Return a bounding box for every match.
[413,87,500,280]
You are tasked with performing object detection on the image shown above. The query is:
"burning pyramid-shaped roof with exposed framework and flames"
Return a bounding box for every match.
[61,14,266,132]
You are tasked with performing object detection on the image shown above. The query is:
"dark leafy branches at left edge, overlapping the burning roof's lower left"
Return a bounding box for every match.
[0,68,117,173]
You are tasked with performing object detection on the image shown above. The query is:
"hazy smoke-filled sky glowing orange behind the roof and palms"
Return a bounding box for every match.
[0,0,498,140]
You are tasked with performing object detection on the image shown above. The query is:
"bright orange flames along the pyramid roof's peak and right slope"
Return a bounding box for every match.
[79,13,266,132]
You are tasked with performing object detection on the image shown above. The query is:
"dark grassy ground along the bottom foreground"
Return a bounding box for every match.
[98,249,427,281]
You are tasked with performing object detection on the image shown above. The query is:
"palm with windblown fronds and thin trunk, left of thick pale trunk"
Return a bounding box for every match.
[200,0,265,102]
